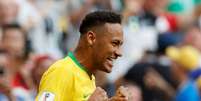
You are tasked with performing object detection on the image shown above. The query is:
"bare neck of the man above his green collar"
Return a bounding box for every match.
[74,42,95,75]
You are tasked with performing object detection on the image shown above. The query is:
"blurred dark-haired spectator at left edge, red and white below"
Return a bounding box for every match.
[1,24,32,100]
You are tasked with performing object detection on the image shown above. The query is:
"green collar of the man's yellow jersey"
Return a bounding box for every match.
[68,52,87,72]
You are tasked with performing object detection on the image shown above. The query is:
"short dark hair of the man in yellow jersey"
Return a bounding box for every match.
[79,11,121,35]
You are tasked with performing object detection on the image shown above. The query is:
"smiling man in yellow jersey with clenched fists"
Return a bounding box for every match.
[36,11,128,101]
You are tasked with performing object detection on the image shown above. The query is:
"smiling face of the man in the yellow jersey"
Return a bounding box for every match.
[92,23,123,73]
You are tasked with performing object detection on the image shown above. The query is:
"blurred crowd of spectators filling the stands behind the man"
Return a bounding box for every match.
[0,0,201,101]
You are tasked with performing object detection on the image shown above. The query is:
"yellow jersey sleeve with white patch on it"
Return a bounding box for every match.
[36,60,73,101]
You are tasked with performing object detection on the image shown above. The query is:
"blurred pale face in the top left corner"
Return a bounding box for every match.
[0,0,19,25]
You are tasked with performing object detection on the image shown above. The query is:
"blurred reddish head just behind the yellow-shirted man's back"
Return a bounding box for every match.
[32,55,54,86]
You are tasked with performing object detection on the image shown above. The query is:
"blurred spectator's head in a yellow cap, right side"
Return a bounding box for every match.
[166,46,200,77]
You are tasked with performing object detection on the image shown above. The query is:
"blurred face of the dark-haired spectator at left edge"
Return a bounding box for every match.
[2,29,25,56]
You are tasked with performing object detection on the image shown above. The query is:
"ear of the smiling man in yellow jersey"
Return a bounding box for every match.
[87,31,96,46]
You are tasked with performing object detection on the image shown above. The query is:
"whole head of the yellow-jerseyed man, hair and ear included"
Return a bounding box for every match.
[80,11,123,73]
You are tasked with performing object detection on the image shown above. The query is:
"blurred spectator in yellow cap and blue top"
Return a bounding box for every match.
[167,46,200,101]
